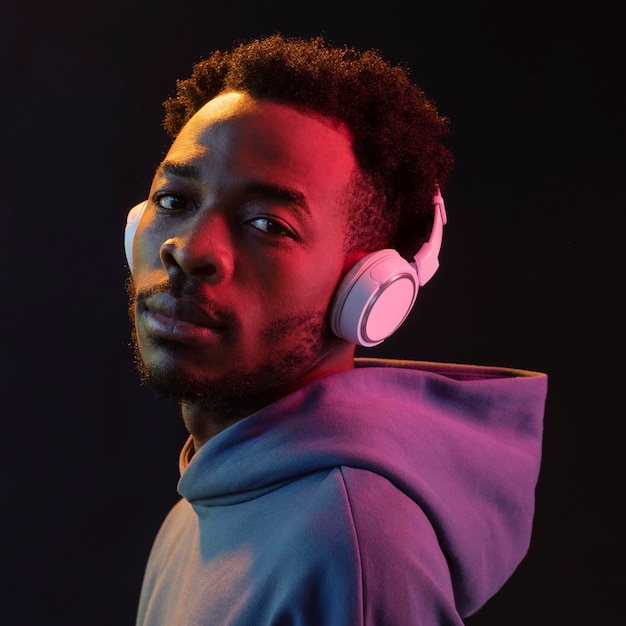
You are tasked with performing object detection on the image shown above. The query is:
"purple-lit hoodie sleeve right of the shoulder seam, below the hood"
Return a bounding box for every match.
[342,467,461,624]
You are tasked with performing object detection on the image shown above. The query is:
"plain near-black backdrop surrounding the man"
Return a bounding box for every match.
[0,0,626,626]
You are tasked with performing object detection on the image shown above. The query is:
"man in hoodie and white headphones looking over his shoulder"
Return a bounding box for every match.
[126,35,546,626]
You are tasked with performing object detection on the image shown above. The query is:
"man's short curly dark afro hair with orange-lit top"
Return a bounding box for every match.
[164,34,454,259]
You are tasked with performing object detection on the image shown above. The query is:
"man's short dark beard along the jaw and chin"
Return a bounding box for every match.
[127,279,337,416]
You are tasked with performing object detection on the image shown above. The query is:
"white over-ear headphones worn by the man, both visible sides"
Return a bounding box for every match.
[124,188,447,347]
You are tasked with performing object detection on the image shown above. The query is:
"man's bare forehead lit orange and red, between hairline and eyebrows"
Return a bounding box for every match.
[161,92,356,202]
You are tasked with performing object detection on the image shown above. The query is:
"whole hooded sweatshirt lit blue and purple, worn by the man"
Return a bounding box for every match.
[137,359,547,626]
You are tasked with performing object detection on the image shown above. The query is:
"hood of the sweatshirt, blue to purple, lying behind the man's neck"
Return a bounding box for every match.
[179,359,547,615]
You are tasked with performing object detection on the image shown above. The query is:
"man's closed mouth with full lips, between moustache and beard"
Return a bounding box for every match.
[138,293,227,345]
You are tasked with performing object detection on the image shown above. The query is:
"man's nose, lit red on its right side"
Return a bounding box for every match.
[160,216,234,283]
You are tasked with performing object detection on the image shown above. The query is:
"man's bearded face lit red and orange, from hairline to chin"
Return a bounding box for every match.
[131,93,357,404]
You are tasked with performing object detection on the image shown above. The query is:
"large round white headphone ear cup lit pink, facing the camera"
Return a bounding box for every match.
[330,249,419,347]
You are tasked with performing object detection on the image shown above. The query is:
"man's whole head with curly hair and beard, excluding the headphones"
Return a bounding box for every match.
[129,37,450,424]
